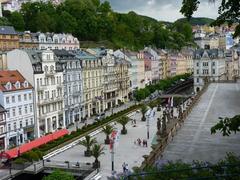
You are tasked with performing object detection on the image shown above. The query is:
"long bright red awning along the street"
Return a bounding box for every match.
[1,129,68,159]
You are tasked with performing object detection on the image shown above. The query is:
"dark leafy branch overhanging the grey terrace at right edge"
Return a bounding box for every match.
[211,115,240,136]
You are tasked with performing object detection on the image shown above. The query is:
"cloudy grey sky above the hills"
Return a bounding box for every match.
[103,0,220,22]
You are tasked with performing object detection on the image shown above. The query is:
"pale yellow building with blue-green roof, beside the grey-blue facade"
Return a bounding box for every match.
[76,49,105,118]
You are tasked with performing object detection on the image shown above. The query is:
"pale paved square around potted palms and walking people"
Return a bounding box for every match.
[50,108,160,179]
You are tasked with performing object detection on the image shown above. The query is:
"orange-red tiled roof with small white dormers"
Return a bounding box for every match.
[0,70,32,91]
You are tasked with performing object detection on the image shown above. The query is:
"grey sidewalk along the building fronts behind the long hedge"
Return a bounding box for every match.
[67,101,134,132]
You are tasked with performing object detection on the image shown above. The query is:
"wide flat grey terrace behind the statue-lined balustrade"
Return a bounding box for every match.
[162,83,240,162]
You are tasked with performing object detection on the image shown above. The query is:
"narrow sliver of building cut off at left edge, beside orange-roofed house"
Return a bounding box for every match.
[0,105,7,151]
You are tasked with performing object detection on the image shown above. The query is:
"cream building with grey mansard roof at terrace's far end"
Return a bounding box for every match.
[193,49,225,92]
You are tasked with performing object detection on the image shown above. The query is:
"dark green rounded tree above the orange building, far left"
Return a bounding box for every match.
[9,11,25,31]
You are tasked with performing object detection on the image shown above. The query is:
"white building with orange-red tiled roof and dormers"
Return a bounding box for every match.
[0,70,34,148]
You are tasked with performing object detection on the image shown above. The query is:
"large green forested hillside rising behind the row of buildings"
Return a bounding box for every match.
[0,0,195,50]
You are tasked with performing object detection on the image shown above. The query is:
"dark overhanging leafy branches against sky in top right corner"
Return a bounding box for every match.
[180,0,240,37]
